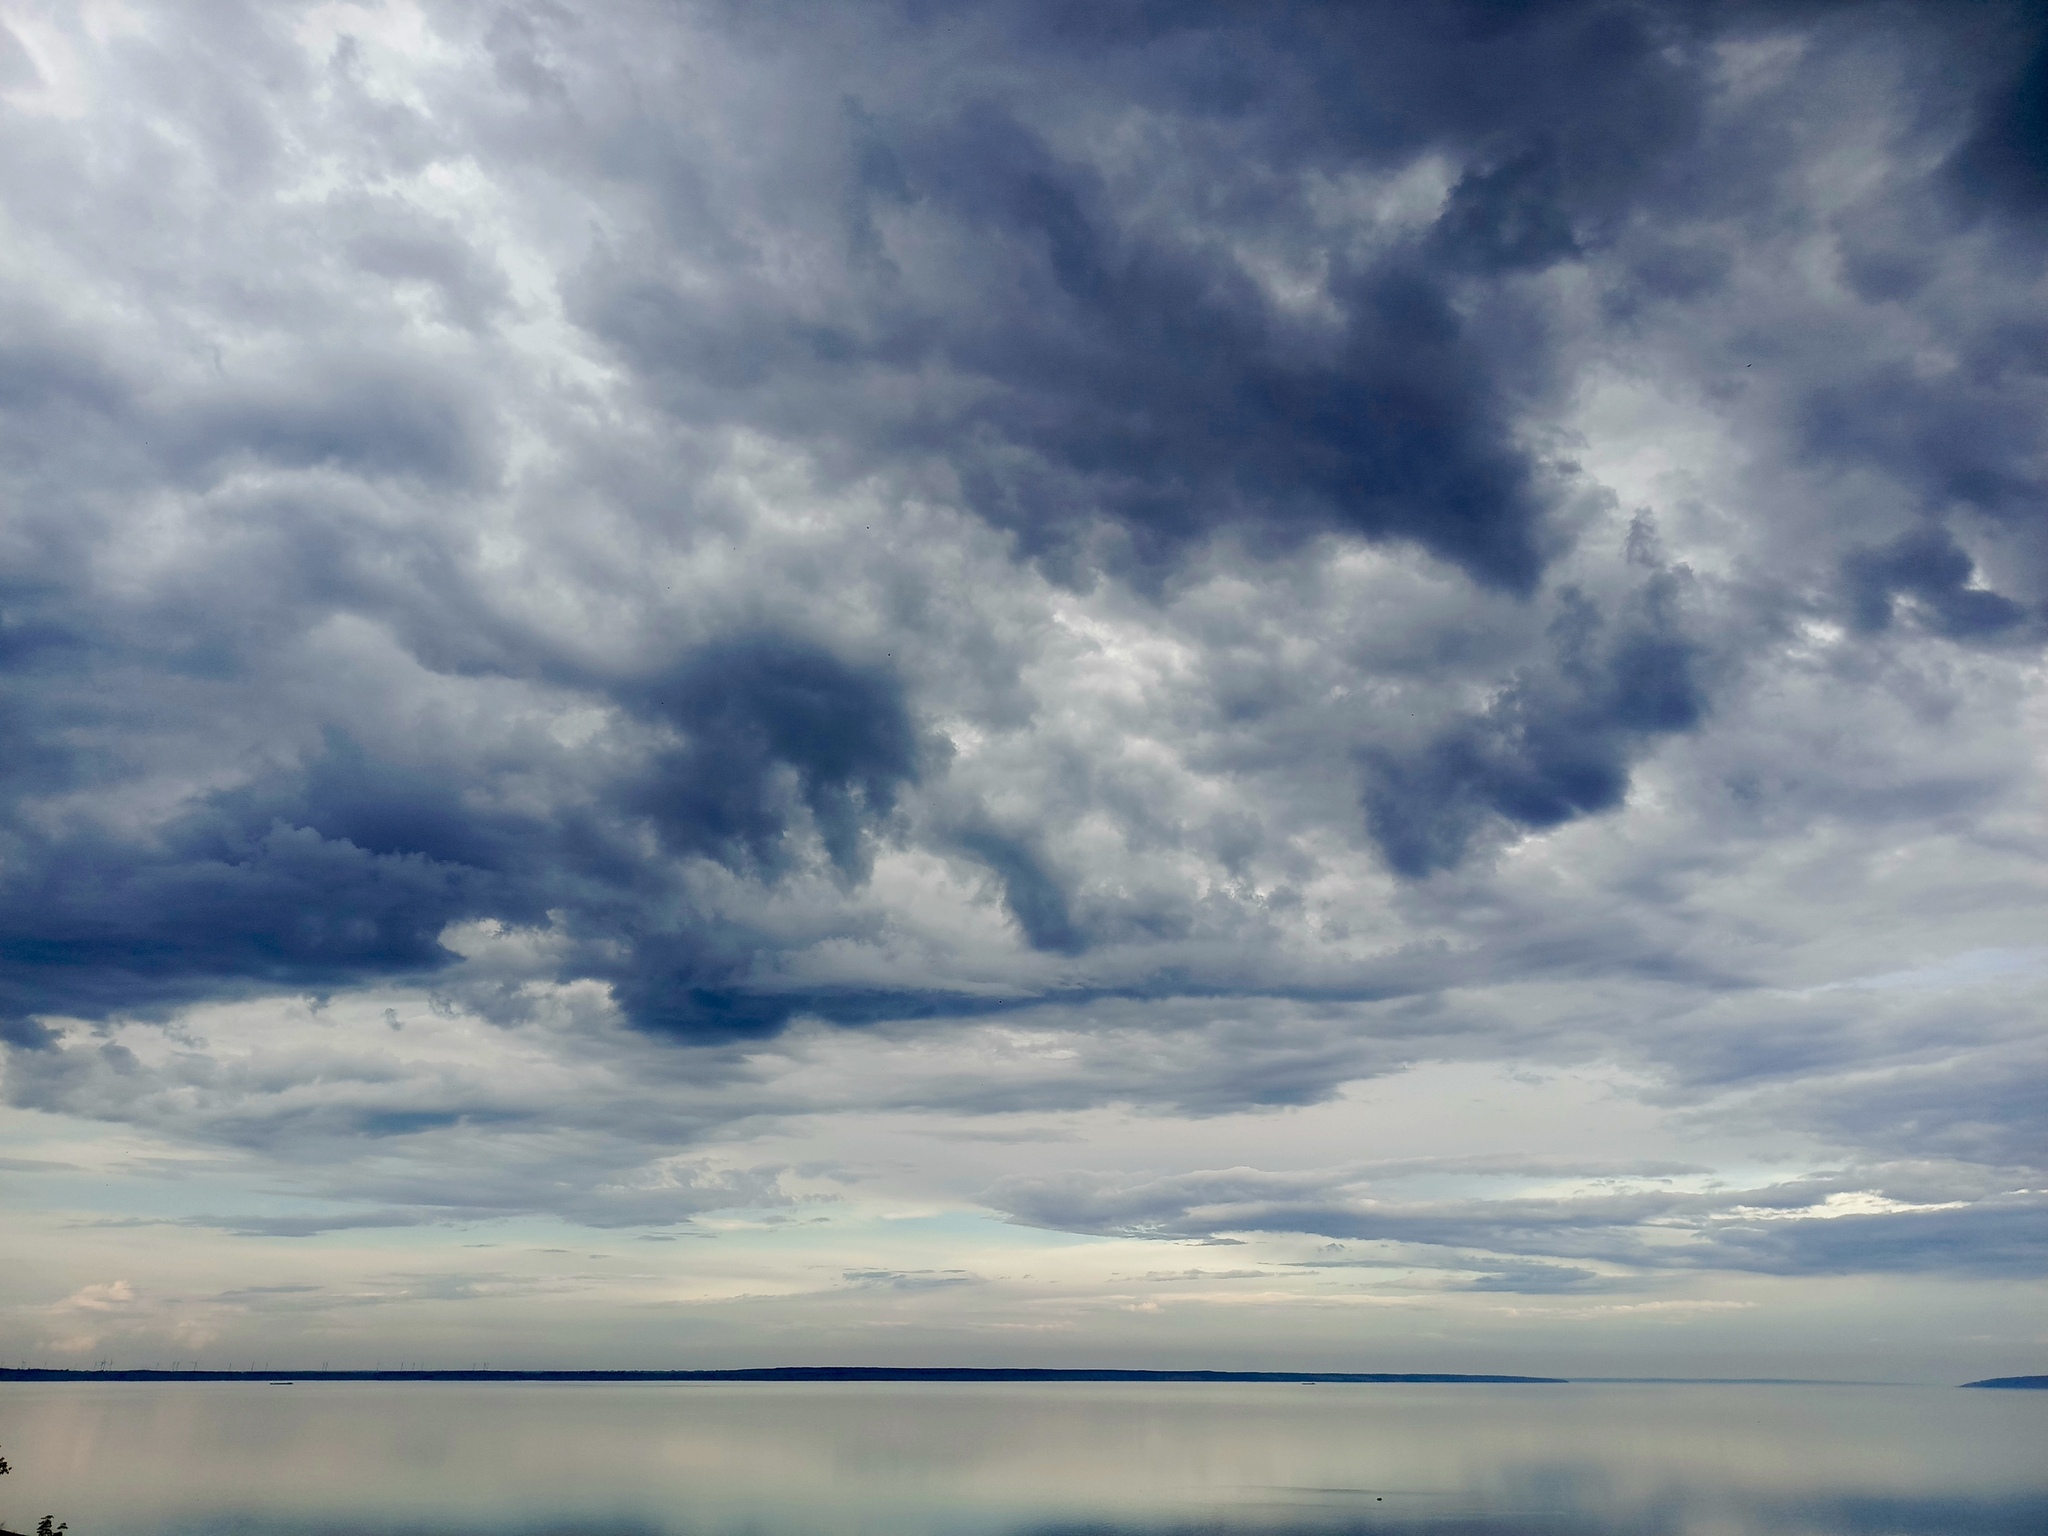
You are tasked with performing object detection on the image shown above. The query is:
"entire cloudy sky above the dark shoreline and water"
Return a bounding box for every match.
[0,0,2048,1380]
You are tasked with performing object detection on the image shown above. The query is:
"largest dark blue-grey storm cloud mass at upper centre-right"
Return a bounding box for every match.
[580,6,1702,592]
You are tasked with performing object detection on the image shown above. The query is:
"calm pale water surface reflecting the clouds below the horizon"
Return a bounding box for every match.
[0,1382,2048,1536]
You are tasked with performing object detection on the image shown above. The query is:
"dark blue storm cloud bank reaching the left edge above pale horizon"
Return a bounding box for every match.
[0,635,922,1042]
